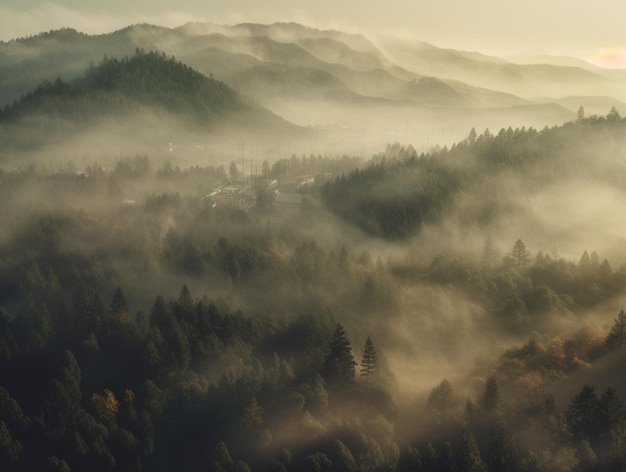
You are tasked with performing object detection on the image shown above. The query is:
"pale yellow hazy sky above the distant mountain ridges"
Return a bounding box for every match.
[0,0,626,67]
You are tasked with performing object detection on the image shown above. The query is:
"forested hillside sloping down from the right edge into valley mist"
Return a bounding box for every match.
[322,107,626,239]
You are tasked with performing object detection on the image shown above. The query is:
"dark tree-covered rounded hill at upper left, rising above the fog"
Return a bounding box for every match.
[0,50,293,132]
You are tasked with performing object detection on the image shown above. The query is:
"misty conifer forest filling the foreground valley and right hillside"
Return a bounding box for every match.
[0,85,626,471]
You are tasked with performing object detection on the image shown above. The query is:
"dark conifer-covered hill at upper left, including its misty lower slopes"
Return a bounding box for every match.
[0,49,298,155]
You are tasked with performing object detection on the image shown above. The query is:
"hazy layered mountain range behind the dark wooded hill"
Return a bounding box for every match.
[0,23,626,107]
